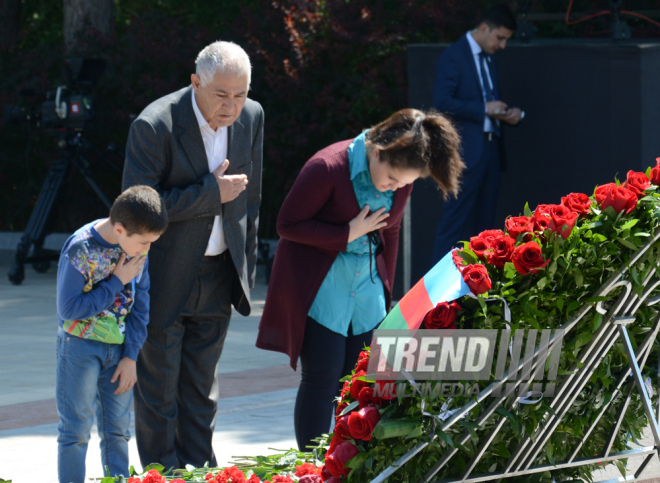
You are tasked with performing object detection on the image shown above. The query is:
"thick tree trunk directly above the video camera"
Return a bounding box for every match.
[64,0,115,57]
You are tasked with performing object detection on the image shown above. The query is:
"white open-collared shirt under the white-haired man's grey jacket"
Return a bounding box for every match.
[191,90,227,257]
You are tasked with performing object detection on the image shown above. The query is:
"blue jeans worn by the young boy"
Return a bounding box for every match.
[56,327,133,483]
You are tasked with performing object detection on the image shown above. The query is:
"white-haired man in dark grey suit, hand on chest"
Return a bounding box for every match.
[123,42,264,468]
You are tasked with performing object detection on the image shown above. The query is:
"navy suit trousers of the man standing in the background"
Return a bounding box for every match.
[433,138,500,264]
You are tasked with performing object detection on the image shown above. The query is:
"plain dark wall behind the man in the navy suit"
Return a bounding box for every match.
[398,40,660,296]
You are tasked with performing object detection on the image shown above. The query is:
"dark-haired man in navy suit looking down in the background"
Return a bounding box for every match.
[433,5,524,263]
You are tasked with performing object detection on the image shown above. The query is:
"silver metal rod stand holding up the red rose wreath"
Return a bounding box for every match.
[371,229,660,483]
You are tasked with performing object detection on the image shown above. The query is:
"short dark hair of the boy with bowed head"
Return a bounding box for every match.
[110,185,169,236]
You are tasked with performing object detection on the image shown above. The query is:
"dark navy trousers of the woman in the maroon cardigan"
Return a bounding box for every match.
[293,317,372,451]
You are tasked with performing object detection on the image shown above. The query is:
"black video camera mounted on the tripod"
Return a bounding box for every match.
[5,59,106,131]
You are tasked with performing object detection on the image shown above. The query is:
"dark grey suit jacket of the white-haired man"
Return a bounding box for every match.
[122,86,264,328]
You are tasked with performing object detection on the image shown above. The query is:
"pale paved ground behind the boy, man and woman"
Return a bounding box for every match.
[0,264,660,483]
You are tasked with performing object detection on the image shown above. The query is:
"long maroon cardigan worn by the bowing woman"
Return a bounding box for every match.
[257,139,412,370]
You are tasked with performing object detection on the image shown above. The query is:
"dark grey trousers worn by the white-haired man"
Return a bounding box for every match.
[134,255,236,469]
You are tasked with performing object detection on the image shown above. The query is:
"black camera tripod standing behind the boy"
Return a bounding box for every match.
[8,131,120,285]
